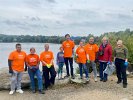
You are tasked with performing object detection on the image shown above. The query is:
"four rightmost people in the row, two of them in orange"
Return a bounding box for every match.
[76,37,128,88]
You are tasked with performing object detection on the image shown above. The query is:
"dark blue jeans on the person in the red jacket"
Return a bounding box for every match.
[99,62,108,80]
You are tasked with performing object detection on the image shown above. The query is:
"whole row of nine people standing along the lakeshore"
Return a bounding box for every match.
[8,34,128,94]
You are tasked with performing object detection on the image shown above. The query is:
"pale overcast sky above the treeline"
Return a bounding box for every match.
[0,0,133,36]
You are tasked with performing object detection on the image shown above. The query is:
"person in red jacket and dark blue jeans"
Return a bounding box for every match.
[99,37,112,82]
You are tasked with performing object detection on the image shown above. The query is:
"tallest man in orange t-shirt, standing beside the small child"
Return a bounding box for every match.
[62,34,75,79]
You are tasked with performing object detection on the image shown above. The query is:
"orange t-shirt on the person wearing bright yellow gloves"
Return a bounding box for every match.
[40,51,54,66]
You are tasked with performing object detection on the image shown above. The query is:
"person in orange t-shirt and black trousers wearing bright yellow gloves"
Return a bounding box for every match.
[40,44,56,89]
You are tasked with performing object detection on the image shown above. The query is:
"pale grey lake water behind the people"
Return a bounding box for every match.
[0,43,78,68]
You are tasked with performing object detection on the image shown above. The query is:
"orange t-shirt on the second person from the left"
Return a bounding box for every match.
[26,54,39,66]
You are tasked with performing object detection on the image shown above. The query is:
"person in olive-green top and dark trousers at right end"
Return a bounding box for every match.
[114,40,128,88]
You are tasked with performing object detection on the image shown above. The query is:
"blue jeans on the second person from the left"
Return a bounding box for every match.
[28,68,43,90]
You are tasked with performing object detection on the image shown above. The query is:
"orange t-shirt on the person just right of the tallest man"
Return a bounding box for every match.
[76,46,87,64]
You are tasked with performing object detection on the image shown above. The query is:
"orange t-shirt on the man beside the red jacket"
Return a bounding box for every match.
[85,43,99,61]
